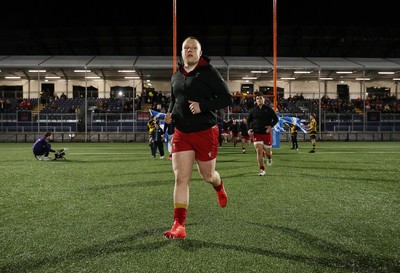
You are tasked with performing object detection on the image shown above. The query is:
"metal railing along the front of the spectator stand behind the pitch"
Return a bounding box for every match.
[0,111,400,133]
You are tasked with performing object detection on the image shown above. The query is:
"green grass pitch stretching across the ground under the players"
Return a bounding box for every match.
[0,141,400,273]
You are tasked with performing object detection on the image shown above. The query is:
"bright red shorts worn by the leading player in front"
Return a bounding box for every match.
[172,126,219,161]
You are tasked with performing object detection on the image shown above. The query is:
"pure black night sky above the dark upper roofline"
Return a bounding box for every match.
[0,0,399,28]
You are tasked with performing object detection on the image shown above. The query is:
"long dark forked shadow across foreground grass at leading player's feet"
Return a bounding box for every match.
[0,223,400,273]
